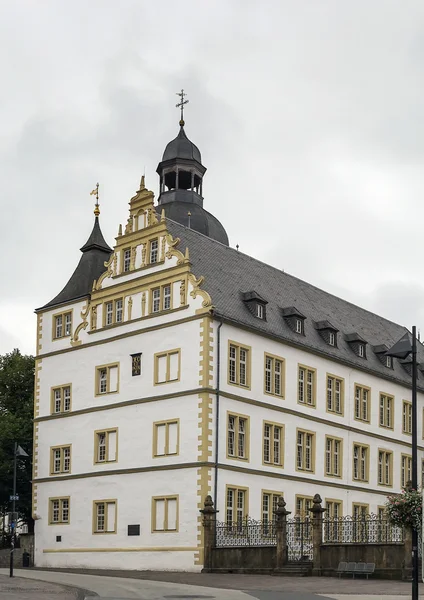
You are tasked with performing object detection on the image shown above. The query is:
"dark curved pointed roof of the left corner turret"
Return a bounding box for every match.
[37,217,112,310]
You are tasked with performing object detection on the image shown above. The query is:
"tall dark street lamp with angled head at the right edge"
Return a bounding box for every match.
[386,325,418,600]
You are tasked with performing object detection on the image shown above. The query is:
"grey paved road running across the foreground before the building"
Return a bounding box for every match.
[0,569,424,600]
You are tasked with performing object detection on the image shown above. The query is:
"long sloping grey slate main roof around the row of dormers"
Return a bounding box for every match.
[167,219,424,388]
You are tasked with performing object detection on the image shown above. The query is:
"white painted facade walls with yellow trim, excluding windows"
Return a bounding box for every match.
[34,179,423,570]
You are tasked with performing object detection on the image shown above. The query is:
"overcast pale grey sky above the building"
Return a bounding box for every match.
[0,0,424,353]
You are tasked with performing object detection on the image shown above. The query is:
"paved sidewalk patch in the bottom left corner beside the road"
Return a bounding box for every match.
[0,575,80,600]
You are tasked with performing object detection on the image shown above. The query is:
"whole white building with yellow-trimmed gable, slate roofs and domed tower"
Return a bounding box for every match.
[34,115,424,570]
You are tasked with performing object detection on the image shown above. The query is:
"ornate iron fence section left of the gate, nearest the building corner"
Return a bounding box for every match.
[215,517,277,547]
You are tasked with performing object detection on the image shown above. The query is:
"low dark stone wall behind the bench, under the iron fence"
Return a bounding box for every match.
[321,543,405,579]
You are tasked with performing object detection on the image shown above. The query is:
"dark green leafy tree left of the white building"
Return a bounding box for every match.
[0,349,35,532]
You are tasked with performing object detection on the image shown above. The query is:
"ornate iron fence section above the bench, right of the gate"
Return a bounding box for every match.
[323,514,403,544]
